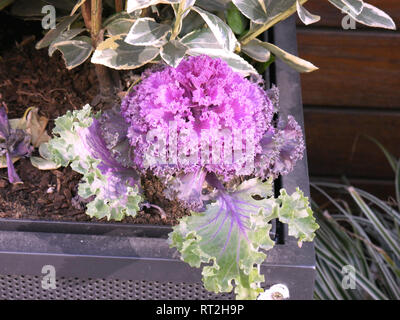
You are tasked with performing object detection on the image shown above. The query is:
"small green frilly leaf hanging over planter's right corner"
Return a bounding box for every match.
[277,188,319,246]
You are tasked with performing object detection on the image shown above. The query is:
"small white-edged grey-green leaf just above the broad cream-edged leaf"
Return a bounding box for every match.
[125,18,171,47]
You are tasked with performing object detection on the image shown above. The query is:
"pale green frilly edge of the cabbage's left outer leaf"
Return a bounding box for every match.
[47,105,142,221]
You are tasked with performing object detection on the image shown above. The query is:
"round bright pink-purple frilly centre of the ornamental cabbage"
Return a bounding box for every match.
[121,55,273,180]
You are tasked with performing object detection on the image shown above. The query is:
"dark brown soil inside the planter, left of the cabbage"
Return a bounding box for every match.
[0,14,187,225]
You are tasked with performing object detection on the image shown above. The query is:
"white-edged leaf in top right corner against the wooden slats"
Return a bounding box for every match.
[328,0,396,30]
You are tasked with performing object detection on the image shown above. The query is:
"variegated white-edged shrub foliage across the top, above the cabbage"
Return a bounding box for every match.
[0,0,396,76]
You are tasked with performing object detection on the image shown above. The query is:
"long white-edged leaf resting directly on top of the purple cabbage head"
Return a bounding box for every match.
[187,48,257,77]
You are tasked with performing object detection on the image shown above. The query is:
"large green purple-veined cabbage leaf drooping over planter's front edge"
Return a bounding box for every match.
[169,179,276,299]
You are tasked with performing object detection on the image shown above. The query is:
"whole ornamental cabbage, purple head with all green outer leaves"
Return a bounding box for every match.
[49,55,318,299]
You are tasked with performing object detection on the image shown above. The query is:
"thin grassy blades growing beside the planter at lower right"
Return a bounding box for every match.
[313,144,400,300]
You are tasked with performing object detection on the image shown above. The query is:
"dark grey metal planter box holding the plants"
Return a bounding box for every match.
[0,18,315,299]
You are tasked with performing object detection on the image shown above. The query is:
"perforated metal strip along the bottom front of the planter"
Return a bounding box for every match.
[0,275,234,300]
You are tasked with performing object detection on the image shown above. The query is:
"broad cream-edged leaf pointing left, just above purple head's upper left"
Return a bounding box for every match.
[91,35,160,70]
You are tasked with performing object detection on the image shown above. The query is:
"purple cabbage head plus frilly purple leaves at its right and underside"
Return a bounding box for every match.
[121,55,304,204]
